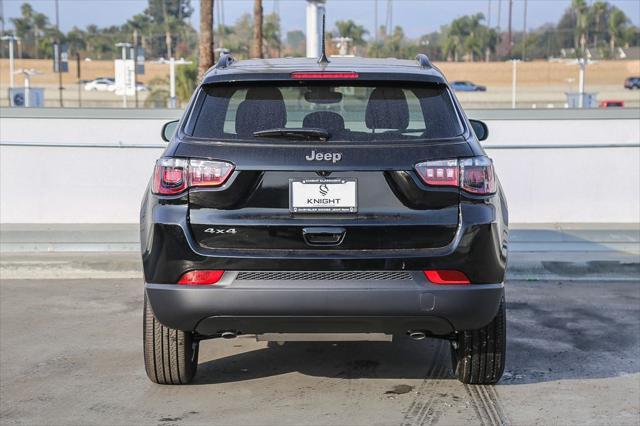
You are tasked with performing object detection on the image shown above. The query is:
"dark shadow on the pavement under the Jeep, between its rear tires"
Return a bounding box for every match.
[194,337,453,384]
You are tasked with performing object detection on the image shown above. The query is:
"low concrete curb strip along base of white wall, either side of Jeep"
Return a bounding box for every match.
[0,224,640,282]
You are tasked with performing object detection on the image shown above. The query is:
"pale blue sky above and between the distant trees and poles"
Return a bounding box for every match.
[0,0,640,37]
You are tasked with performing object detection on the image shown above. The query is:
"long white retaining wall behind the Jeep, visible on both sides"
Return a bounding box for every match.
[0,109,640,223]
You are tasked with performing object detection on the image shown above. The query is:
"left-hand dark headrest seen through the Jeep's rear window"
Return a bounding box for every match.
[236,87,287,137]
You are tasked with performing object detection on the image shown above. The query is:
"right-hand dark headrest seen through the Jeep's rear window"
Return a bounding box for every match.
[365,87,409,130]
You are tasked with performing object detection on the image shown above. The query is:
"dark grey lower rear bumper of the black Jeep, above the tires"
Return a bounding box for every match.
[145,273,504,336]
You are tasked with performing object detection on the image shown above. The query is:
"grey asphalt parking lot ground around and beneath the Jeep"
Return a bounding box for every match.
[0,272,640,425]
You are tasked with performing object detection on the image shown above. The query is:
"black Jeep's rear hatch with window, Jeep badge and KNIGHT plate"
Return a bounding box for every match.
[173,81,472,254]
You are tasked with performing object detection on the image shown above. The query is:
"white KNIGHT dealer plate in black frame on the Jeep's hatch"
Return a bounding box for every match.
[289,178,358,214]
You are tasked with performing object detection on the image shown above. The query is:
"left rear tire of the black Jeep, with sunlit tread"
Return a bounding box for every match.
[143,293,198,385]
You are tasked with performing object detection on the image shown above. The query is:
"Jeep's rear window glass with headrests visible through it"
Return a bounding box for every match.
[185,83,463,142]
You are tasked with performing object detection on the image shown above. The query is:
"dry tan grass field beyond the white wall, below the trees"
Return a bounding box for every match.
[0,59,640,108]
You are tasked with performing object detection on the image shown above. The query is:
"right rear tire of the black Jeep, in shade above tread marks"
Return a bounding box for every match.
[451,299,507,385]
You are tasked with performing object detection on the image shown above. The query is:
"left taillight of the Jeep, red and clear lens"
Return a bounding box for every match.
[153,158,233,195]
